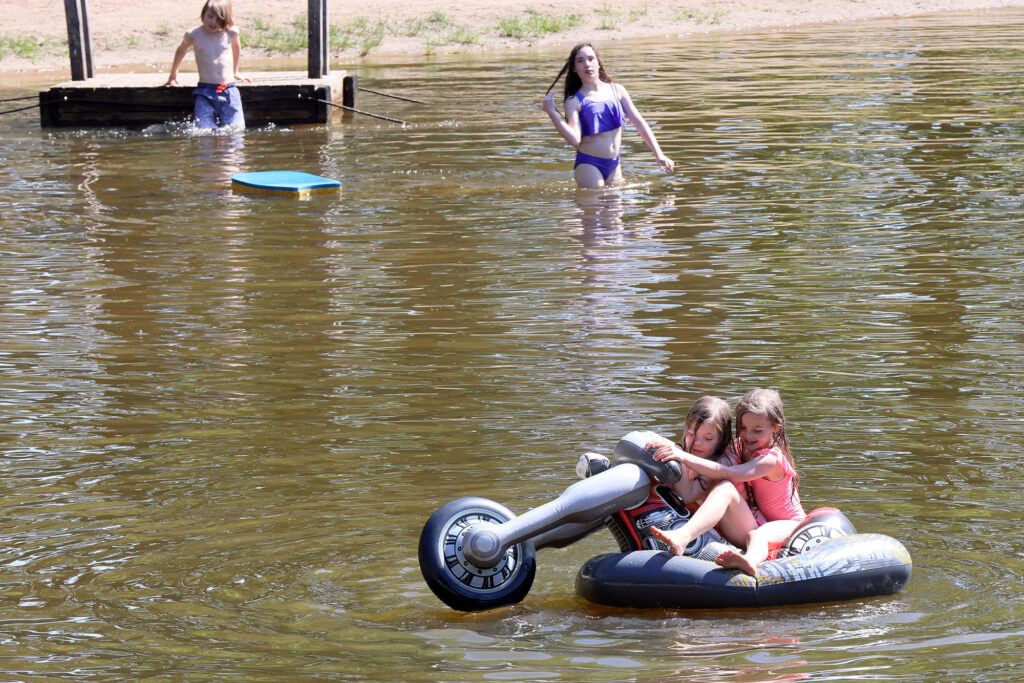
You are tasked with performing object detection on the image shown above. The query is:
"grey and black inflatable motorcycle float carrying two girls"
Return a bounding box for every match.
[419,432,912,611]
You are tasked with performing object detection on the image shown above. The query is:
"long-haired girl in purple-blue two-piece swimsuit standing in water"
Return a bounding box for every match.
[540,43,676,187]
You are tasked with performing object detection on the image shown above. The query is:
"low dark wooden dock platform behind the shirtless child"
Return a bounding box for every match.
[39,72,358,128]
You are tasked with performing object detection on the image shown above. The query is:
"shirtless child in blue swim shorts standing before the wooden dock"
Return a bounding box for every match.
[165,0,250,128]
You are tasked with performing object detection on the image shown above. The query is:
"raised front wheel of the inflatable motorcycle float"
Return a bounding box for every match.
[419,498,537,611]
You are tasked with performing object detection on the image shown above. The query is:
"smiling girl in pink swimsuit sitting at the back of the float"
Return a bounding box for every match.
[651,389,807,575]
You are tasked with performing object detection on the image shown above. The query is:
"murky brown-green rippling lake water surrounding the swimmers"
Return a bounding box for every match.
[0,13,1024,681]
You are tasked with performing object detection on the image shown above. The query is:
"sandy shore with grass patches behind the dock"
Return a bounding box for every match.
[0,0,1024,78]
